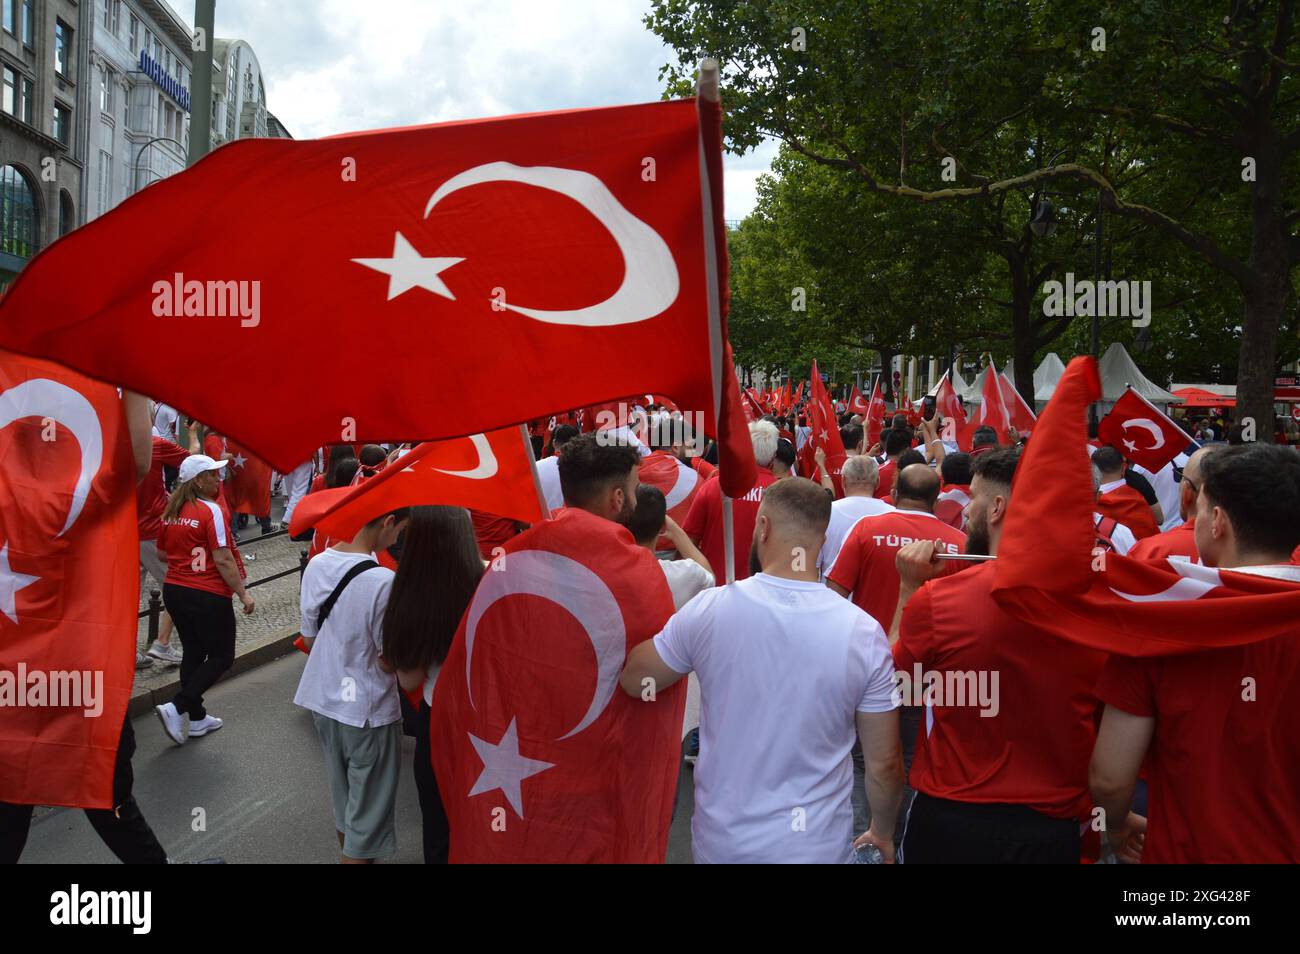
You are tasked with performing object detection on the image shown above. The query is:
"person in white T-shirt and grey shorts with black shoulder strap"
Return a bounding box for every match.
[294,508,410,864]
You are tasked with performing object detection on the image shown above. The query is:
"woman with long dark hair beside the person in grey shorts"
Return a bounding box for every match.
[384,507,484,864]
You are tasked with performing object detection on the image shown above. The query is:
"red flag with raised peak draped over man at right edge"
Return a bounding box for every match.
[993,357,1300,656]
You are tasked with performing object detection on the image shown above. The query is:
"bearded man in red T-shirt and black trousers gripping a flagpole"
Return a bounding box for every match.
[889,447,1106,864]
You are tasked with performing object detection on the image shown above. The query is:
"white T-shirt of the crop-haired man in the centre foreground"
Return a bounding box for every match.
[654,573,896,864]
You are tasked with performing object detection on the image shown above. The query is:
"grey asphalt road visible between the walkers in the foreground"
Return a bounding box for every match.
[22,652,693,864]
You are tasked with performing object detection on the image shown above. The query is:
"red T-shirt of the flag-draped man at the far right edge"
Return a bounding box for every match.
[1097,565,1300,864]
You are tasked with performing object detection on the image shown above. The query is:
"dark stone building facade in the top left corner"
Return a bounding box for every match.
[0,0,90,291]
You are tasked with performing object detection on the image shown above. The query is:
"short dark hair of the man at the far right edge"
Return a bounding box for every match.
[1201,442,1300,554]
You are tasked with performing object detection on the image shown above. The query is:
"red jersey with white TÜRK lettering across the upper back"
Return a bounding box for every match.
[826,509,966,632]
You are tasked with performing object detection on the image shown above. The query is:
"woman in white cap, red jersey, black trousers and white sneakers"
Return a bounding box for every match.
[155,454,254,745]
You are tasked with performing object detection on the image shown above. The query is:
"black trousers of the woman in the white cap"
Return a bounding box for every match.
[163,584,235,719]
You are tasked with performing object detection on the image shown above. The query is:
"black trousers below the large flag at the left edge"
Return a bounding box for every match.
[0,719,166,864]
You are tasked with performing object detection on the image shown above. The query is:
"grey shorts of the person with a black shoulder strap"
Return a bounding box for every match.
[312,712,402,858]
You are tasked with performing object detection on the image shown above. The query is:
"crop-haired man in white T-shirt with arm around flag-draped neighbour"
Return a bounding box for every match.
[620,477,902,863]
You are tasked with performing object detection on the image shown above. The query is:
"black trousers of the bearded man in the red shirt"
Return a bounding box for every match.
[902,792,1079,864]
